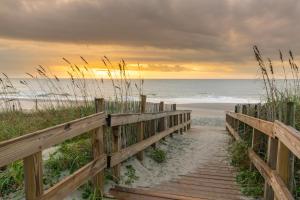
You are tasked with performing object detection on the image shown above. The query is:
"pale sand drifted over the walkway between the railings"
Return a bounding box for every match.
[118,126,229,187]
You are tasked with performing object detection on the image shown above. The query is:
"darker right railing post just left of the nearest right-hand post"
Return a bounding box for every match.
[264,104,278,200]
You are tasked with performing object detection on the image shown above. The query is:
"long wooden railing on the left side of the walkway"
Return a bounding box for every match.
[0,97,191,200]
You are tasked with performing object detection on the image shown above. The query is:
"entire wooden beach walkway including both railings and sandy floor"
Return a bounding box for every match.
[0,98,300,200]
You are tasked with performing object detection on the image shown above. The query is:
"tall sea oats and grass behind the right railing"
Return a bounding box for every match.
[253,46,300,199]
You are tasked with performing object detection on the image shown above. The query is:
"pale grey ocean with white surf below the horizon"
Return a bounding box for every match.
[0,79,264,104]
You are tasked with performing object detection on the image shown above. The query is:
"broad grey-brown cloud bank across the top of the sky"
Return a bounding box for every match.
[0,0,300,62]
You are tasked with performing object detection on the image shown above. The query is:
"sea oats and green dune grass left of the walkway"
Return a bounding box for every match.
[0,56,148,199]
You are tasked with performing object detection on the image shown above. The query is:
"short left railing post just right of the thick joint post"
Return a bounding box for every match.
[112,126,122,180]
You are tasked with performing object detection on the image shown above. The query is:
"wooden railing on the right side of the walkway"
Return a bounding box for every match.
[226,104,300,199]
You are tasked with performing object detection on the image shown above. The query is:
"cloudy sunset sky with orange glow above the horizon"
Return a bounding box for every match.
[0,0,300,79]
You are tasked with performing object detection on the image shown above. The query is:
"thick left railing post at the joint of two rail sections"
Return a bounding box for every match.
[92,98,105,194]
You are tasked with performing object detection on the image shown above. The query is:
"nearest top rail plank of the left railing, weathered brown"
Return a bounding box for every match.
[0,113,106,167]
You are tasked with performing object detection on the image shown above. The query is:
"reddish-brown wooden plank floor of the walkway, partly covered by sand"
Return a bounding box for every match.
[111,126,245,200]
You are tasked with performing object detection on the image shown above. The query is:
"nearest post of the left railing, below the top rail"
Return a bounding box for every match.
[23,151,43,200]
